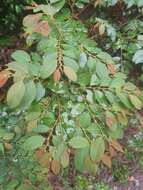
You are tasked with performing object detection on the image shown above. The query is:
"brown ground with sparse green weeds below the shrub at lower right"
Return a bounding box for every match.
[48,126,143,190]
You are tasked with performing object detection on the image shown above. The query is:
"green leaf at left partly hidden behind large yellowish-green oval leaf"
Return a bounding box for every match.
[18,81,36,110]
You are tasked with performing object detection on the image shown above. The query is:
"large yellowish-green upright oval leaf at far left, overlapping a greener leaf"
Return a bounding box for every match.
[7,81,25,108]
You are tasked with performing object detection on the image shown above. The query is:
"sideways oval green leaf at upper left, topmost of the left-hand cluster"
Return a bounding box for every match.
[11,50,31,63]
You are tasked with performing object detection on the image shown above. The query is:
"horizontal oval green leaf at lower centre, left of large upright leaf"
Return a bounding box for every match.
[69,136,89,149]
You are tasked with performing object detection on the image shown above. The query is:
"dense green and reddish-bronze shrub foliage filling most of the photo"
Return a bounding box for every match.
[0,0,143,190]
